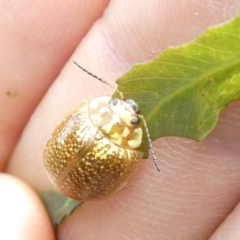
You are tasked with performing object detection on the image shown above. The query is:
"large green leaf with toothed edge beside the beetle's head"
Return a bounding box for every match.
[115,16,240,155]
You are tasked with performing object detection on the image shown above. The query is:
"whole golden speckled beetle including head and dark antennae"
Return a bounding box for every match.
[44,62,159,201]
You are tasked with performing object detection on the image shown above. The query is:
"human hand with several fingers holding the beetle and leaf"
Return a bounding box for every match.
[0,0,240,240]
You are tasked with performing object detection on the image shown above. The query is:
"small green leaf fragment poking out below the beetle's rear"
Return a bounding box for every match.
[39,188,82,225]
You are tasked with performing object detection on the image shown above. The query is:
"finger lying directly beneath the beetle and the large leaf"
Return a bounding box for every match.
[8,0,240,240]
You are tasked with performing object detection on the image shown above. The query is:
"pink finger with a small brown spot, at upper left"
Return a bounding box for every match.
[0,0,108,170]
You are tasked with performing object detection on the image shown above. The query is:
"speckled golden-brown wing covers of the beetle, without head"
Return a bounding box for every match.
[44,97,143,201]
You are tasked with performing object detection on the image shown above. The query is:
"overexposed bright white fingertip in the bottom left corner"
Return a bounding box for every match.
[0,174,54,240]
